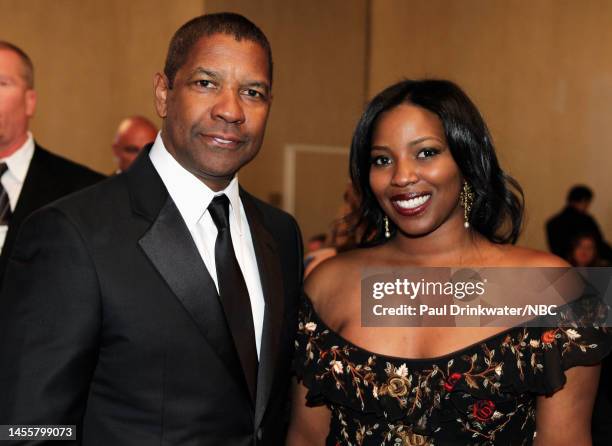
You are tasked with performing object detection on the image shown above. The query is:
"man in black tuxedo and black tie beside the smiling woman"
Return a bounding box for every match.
[0,13,302,446]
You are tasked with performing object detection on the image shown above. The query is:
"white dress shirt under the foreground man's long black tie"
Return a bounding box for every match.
[149,133,265,356]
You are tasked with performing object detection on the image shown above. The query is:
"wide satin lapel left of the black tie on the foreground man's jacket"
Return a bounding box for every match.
[139,188,246,398]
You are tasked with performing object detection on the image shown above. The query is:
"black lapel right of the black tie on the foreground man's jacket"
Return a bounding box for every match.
[240,190,284,426]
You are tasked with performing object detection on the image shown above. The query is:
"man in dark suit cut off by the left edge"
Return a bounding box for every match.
[0,41,103,286]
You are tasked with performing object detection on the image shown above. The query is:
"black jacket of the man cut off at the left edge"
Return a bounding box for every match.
[0,144,104,286]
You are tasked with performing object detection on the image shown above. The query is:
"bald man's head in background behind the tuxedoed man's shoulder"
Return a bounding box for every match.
[113,116,157,173]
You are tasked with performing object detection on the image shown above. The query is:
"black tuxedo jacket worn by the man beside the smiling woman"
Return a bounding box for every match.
[0,150,302,446]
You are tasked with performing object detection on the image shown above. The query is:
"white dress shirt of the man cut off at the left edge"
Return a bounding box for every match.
[0,132,34,249]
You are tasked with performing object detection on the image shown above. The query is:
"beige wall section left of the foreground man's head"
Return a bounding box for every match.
[0,0,203,173]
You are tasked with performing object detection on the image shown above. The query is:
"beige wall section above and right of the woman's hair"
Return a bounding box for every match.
[369,0,612,248]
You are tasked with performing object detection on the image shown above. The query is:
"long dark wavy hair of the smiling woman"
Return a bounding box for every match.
[350,79,524,246]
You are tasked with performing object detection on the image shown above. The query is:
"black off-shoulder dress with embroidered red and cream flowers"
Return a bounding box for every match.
[294,298,610,446]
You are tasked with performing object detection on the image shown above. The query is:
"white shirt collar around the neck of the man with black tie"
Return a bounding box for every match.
[149,132,242,234]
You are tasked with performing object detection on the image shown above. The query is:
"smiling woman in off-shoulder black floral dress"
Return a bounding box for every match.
[288,80,609,446]
